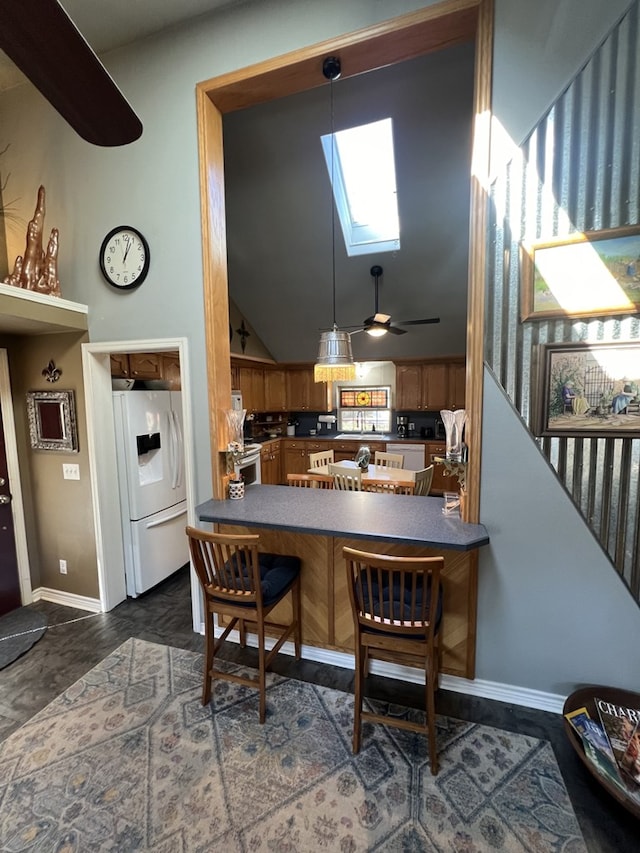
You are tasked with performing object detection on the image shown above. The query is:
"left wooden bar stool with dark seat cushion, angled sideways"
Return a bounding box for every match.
[186,527,302,723]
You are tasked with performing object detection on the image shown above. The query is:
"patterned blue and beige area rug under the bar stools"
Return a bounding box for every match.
[0,640,587,853]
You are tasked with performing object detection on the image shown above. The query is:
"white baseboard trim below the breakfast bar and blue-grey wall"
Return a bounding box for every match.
[208,625,566,714]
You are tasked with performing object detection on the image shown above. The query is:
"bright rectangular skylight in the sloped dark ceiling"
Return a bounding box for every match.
[321,118,400,256]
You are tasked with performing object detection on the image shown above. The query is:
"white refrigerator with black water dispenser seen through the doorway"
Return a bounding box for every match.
[113,391,189,598]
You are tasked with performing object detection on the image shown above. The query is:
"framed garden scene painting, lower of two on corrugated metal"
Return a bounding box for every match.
[536,341,640,438]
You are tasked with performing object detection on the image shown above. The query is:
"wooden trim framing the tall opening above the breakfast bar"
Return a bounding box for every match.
[196,0,493,521]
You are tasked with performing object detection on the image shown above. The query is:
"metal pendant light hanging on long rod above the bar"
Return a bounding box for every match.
[313,56,356,382]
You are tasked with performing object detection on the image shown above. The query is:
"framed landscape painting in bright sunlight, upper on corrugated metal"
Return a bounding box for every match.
[520,225,640,321]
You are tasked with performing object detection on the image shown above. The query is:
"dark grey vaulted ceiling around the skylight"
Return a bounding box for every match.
[224,43,474,361]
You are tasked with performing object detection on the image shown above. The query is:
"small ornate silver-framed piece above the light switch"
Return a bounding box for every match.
[27,391,78,453]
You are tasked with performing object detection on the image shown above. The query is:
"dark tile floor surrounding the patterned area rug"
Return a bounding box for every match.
[0,567,640,853]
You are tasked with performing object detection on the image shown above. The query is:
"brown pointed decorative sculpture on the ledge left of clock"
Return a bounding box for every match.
[5,186,62,296]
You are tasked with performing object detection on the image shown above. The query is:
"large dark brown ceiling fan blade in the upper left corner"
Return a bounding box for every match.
[0,0,142,146]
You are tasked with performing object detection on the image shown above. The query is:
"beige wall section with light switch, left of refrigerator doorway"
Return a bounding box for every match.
[0,333,99,598]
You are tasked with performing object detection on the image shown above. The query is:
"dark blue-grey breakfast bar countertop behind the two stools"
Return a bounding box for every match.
[196,485,489,551]
